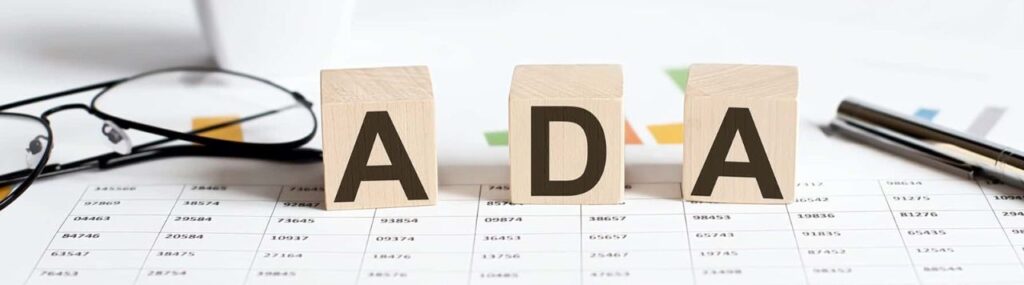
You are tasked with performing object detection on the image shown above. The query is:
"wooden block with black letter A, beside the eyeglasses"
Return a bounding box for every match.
[321,67,437,210]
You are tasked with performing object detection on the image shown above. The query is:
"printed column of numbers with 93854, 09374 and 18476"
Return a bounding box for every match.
[359,186,480,284]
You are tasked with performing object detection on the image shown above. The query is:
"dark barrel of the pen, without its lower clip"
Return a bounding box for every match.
[837,99,1024,169]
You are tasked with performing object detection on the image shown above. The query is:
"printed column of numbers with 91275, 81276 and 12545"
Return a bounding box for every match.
[881,180,1024,284]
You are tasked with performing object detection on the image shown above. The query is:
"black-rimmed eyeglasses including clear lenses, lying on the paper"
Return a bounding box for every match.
[0,68,322,210]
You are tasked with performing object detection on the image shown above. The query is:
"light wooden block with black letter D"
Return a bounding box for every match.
[509,65,625,204]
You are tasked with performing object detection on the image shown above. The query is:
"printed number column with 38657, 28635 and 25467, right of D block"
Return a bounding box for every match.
[583,184,692,284]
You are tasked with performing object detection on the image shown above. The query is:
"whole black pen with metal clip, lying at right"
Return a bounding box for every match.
[829,98,1024,189]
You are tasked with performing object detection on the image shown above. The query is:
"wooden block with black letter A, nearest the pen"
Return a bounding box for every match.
[683,65,797,204]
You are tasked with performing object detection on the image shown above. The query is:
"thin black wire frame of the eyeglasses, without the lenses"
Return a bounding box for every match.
[0,67,323,210]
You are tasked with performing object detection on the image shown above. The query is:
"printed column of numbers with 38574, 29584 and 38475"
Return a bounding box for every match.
[138,186,281,284]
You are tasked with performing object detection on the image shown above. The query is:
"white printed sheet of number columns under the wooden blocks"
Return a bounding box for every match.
[4,179,1024,284]
